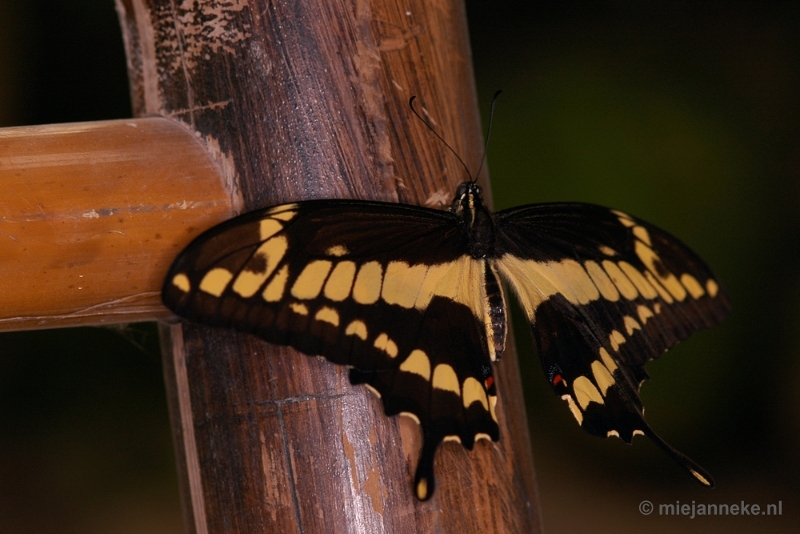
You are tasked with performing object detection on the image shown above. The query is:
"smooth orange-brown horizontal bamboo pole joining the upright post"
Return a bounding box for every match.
[0,118,233,331]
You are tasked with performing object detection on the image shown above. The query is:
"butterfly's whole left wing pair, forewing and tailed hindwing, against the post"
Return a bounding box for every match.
[163,200,499,499]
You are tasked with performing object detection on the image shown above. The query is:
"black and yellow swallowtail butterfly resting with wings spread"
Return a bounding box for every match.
[162,182,730,500]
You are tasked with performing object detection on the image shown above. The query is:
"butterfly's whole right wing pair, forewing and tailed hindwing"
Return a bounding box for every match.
[496,203,730,486]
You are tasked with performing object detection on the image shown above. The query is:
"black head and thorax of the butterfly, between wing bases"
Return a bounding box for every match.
[450,182,495,259]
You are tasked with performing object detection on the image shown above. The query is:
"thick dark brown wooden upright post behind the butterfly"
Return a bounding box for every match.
[117,0,540,533]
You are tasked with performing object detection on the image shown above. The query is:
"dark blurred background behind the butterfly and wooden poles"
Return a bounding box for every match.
[0,0,800,533]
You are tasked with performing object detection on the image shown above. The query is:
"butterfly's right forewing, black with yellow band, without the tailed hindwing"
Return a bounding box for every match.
[496,203,730,370]
